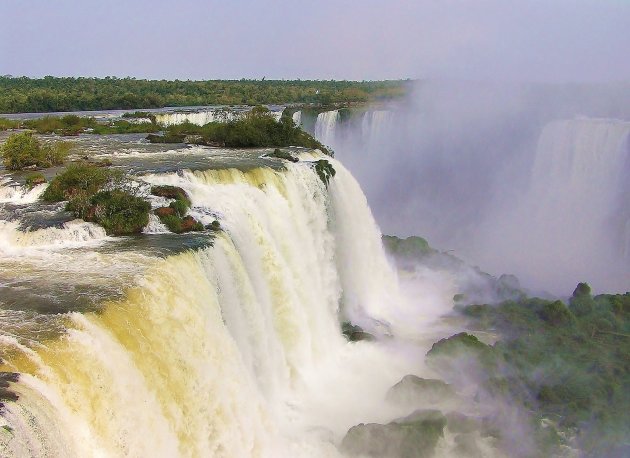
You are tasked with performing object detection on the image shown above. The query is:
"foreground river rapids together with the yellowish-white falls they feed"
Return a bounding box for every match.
[0,138,474,457]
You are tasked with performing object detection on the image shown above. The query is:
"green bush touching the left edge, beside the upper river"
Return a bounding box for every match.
[0,132,73,170]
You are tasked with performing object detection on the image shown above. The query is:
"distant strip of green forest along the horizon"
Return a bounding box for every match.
[0,76,407,113]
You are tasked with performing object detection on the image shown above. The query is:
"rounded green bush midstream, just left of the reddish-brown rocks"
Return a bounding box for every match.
[85,189,151,235]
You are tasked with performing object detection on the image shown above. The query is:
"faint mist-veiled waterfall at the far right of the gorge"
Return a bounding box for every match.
[481,119,630,292]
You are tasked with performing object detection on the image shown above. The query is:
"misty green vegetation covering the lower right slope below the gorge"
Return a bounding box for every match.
[442,283,630,456]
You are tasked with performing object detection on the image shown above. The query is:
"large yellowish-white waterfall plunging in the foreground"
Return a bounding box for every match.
[0,153,417,457]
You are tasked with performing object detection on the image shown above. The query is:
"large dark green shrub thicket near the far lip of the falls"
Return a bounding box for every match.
[152,106,332,155]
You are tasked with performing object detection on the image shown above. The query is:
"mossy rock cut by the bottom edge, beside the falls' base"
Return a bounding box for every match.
[341,410,446,458]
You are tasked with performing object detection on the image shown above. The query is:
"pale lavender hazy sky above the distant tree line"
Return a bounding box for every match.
[0,0,630,81]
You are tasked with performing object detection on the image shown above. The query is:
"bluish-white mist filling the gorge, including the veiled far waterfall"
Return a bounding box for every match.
[335,81,630,294]
